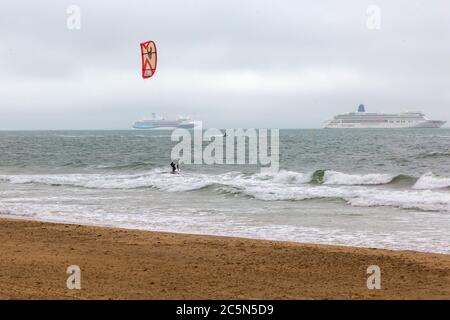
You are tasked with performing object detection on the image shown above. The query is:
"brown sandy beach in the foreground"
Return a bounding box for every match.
[0,219,450,299]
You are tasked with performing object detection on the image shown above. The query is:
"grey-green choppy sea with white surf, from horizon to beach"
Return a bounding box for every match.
[0,129,450,254]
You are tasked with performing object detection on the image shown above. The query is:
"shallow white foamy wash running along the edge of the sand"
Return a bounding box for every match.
[0,203,450,254]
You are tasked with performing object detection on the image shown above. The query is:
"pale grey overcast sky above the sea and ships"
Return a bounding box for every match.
[0,0,450,130]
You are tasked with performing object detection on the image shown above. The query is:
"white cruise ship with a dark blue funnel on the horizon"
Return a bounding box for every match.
[324,104,446,129]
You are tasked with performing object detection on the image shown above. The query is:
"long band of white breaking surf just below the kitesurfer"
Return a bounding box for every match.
[0,169,450,212]
